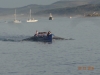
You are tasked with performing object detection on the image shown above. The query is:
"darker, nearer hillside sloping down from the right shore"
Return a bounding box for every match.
[35,4,100,16]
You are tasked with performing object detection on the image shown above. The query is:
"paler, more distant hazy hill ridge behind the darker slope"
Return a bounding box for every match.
[0,1,88,15]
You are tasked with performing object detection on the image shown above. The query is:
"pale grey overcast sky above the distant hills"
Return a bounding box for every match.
[0,0,59,8]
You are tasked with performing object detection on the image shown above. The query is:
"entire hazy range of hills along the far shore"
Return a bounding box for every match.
[0,0,100,16]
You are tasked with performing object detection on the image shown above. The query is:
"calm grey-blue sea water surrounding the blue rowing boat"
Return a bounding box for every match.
[0,17,100,75]
